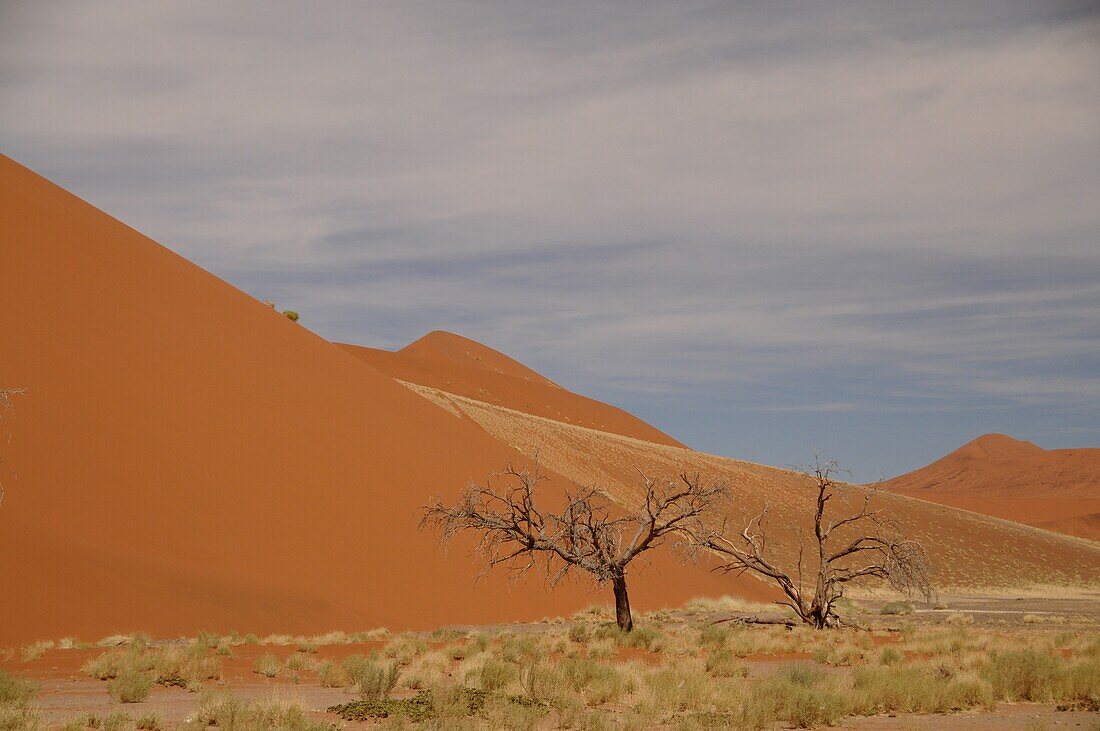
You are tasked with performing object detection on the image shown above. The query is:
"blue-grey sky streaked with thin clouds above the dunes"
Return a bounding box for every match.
[0,0,1100,481]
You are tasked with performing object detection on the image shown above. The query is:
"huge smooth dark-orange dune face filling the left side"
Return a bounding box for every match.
[0,157,748,644]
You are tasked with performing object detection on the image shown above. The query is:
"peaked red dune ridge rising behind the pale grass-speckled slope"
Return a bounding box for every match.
[341,331,683,446]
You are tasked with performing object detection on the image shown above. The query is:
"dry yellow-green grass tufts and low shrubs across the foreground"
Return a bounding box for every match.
[0,600,1100,731]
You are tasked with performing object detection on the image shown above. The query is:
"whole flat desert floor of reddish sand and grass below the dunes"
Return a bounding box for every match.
[0,595,1100,731]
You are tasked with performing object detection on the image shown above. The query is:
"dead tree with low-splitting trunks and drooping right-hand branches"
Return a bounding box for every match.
[693,450,932,629]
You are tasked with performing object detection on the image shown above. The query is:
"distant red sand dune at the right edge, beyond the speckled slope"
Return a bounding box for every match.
[882,434,1100,541]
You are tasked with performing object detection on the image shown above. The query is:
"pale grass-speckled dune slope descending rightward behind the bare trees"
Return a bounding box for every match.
[409,385,1100,590]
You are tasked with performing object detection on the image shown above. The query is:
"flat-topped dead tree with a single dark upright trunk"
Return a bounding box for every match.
[420,463,725,632]
